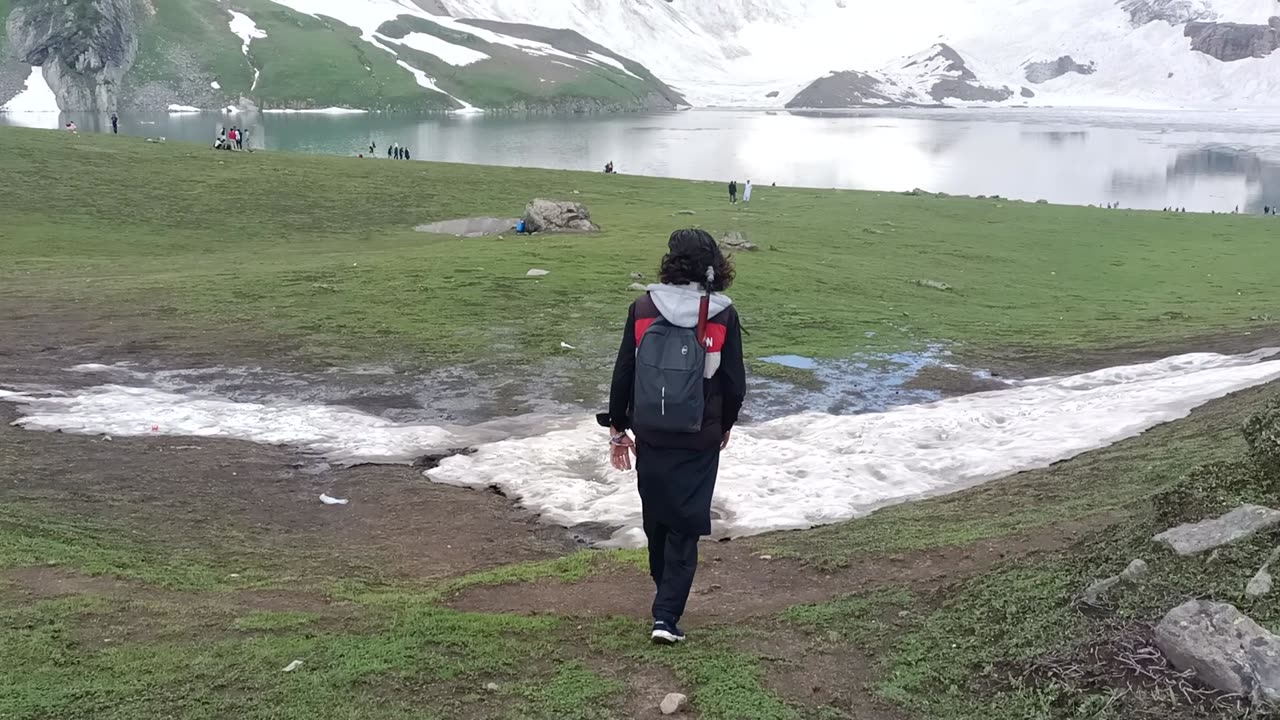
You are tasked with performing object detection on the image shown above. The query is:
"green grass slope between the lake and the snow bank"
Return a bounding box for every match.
[0,129,1280,363]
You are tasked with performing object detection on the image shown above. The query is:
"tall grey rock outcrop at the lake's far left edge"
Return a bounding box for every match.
[6,0,138,111]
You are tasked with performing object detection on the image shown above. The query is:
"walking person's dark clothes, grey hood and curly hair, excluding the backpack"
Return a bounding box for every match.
[600,229,746,644]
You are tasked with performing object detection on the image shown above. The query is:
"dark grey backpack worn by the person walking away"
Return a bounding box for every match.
[631,289,710,433]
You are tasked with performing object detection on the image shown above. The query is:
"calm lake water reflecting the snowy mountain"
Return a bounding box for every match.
[0,109,1280,211]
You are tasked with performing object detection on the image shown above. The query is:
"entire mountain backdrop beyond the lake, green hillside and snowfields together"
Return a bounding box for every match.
[0,0,1280,111]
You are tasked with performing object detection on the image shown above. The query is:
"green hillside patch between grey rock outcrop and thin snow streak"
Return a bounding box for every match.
[129,0,253,99]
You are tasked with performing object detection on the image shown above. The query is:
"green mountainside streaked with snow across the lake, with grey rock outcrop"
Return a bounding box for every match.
[0,0,684,111]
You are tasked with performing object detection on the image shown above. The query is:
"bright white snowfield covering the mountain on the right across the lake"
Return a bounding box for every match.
[440,0,1280,108]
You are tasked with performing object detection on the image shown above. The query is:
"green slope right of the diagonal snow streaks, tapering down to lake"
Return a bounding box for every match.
[379,15,670,108]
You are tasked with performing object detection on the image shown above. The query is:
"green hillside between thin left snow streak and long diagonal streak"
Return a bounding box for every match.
[234,0,452,110]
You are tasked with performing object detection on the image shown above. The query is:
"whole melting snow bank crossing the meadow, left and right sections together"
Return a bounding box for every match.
[0,350,1280,544]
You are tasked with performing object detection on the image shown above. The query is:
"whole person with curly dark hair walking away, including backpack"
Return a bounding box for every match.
[599,229,746,644]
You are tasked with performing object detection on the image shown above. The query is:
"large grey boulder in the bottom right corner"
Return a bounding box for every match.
[1156,600,1280,703]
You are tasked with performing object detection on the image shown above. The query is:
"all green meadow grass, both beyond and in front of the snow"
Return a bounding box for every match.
[0,126,1280,720]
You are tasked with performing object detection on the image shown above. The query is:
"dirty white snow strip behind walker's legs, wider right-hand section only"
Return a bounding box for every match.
[428,350,1280,544]
